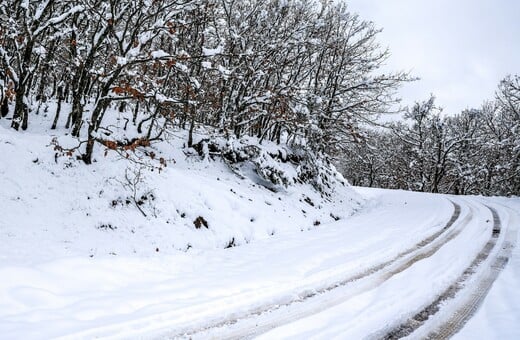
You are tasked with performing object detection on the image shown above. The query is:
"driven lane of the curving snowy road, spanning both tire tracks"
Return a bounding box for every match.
[161,193,517,339]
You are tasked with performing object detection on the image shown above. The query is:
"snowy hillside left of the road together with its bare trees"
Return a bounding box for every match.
[0,0,407,255]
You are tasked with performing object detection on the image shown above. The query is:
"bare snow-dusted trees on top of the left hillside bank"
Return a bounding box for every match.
[0,0,407,164]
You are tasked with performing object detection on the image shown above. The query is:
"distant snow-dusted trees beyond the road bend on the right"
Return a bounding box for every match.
[342,76,520,195]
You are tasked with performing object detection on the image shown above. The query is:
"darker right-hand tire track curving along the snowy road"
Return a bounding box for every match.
[382,206,516,339]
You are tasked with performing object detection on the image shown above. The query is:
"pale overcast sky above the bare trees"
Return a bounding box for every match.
[346,0,520,114]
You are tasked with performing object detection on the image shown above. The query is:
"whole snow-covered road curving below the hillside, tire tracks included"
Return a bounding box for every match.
[0,190,520,339]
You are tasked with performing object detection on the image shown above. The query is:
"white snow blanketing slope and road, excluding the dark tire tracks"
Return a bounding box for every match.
[0,113,520,339]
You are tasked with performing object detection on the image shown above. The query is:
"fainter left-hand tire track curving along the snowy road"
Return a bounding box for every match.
[166,201,464,339]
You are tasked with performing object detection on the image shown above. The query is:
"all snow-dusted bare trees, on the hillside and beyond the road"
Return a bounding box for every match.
[0,0,520,194]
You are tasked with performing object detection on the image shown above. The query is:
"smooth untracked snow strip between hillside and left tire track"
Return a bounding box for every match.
[0,183,453,339]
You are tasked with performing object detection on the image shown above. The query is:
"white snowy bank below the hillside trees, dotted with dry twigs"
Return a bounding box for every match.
[0,118,363,264]
